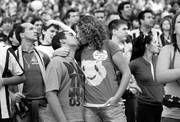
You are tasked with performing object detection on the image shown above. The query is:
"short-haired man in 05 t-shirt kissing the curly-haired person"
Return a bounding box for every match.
[45,31,84,122]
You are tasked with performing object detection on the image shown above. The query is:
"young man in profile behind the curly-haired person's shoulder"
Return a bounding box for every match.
[109,19,139,122]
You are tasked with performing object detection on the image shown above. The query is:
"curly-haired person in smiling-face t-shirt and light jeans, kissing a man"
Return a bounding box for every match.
[76,16,130,122]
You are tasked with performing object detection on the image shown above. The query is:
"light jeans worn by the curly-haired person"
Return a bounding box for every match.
[85,105,127,122]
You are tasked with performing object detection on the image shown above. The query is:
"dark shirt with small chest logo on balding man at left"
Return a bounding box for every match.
[22,51,50,98]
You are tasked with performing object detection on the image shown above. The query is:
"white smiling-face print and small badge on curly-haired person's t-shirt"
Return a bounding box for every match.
[81,50,108,86]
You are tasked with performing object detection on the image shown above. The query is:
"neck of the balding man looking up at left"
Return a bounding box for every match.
[21,40,34,52]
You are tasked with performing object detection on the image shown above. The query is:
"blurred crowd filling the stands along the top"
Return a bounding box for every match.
[0,0,179,27]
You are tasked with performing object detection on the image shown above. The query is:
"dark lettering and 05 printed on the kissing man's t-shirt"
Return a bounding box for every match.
[63,62,85,106]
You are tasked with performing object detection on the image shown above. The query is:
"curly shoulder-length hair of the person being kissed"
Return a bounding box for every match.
[77,15,107,50]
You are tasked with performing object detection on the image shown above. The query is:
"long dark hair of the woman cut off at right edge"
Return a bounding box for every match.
[171,12,180,49]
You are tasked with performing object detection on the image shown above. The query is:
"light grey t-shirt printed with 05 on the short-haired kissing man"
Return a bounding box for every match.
[45,57,85,121]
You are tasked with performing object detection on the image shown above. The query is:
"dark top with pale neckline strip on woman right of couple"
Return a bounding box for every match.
[130,57,164,105]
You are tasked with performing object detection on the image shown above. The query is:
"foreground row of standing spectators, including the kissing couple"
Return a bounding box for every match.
[0,3,180,122]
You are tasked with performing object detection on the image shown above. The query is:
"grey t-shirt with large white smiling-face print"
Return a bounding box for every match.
[81,40,120,104]
